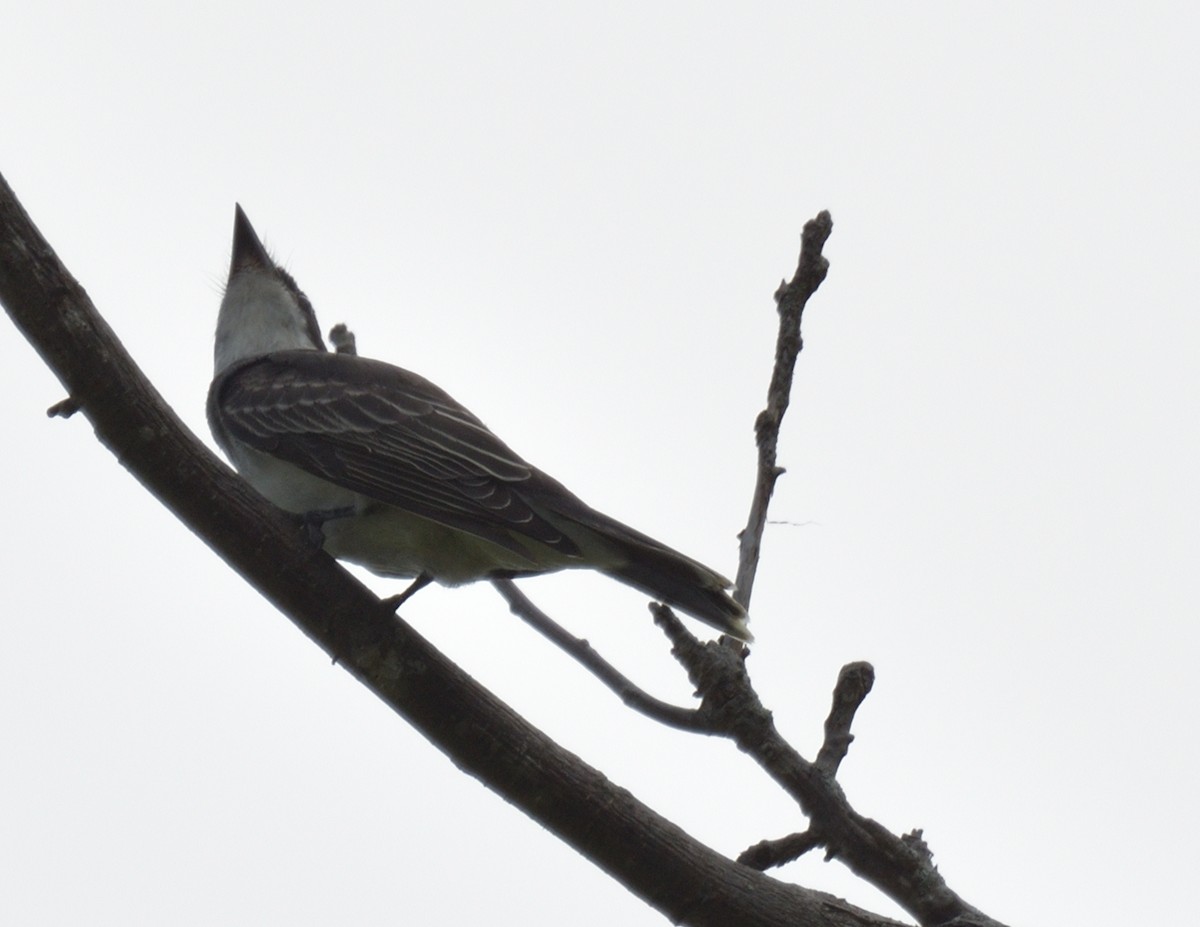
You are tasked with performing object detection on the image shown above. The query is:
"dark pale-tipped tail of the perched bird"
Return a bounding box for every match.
[602,539,754,644]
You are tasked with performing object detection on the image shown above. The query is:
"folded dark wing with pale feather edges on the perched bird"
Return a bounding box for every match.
[209,351,586,557]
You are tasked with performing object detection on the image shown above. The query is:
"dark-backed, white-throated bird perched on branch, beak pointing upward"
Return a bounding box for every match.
[208,207,750,640]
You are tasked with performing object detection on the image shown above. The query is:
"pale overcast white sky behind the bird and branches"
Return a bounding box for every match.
[0,2,1200,927]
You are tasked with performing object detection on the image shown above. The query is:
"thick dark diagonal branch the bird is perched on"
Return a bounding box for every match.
[0,178,894,927]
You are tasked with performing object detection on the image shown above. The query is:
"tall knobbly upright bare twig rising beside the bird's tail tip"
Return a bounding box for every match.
[734,211,833,609]
